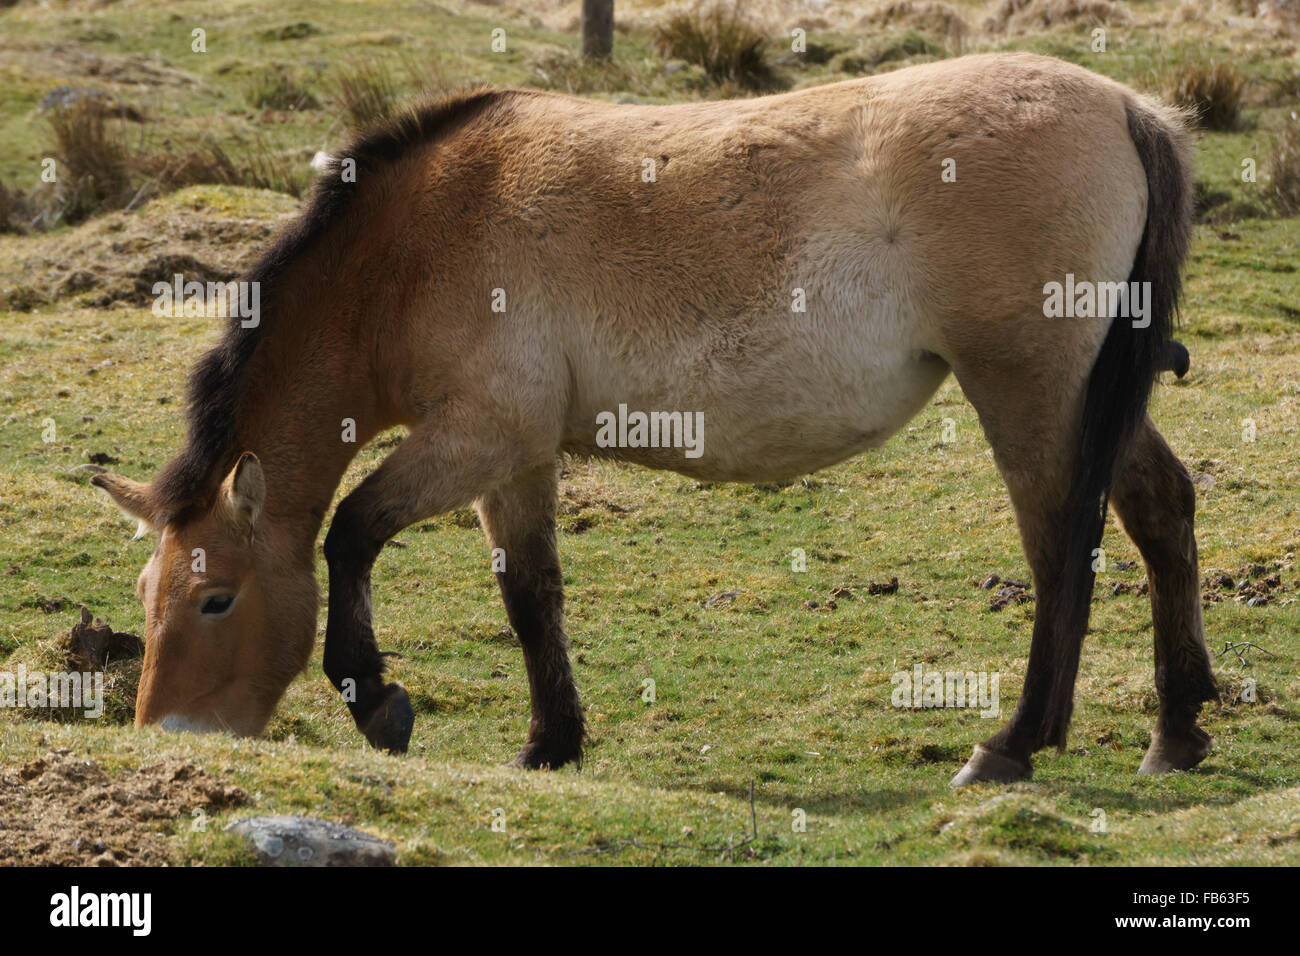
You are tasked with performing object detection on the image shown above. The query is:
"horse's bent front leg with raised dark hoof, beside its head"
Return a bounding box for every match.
[325,423,512,753]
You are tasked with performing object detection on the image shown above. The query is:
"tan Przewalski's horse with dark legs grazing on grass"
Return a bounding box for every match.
[95,55,1216,783]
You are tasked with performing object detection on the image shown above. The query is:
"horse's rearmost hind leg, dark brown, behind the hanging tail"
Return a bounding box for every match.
[1110,419,1217,773]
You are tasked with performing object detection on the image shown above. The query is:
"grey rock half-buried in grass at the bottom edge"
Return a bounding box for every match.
[226,817,398,866]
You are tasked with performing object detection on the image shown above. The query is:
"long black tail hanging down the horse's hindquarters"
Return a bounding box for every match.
[1040,99,1192,749]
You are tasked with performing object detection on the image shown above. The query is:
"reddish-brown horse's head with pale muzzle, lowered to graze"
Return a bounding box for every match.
[91,454,317,736]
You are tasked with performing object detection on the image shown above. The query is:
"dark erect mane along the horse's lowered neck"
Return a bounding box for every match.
[153,90,508,524]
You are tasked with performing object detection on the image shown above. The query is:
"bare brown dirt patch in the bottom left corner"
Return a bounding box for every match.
[0,749,248,866]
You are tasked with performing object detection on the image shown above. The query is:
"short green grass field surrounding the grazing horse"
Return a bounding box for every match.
[0,0,1300,865]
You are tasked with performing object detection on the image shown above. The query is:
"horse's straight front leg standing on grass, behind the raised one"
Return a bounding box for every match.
[476,463,585,769]
